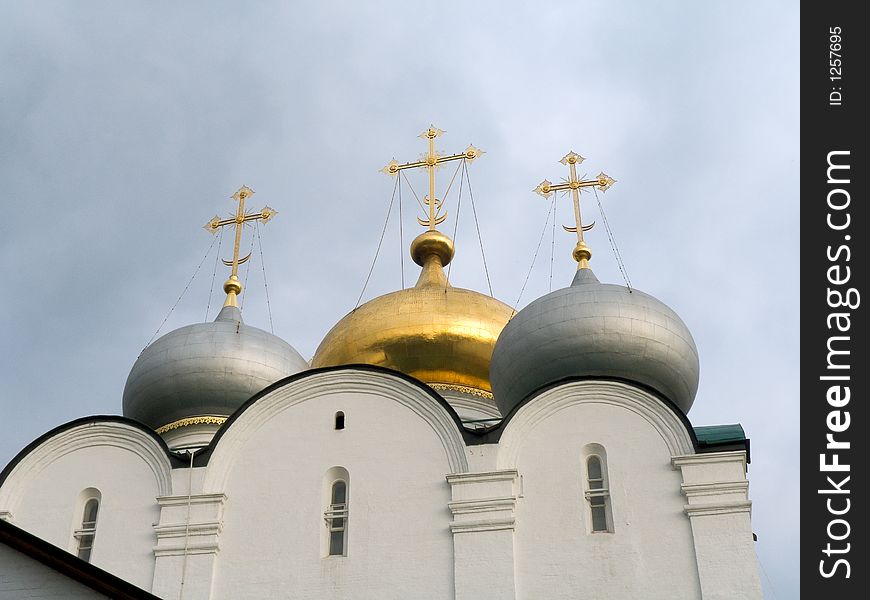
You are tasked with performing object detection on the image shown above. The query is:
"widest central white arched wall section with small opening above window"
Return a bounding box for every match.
[206,373,463,599]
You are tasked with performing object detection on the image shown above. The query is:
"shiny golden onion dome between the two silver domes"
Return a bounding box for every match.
[311,230,514,401]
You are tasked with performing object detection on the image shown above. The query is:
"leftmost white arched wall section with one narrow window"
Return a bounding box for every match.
[0,423,170,590]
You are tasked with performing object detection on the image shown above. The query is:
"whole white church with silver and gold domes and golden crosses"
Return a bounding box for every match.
[0,127,762,600]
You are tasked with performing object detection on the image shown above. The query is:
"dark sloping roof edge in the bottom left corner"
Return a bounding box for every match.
[0,519,160,600]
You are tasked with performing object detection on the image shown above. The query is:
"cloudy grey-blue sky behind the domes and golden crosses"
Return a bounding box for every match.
[0,0,799,598]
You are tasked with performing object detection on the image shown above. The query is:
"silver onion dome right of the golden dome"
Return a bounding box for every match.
[490,268,699,415]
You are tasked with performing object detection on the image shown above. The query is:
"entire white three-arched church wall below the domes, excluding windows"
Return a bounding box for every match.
[0,370,761,600]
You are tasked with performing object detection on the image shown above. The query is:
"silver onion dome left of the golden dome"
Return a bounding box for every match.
[124,306,308,429]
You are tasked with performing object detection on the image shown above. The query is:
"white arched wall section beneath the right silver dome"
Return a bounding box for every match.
[502,383,701,600]
